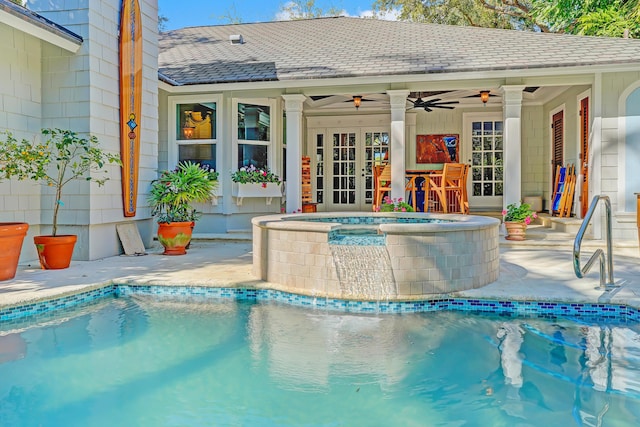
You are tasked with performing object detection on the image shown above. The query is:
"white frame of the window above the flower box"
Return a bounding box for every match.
[231,98,280,174]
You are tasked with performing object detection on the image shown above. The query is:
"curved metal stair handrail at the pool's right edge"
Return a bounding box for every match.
[573,195,615,289]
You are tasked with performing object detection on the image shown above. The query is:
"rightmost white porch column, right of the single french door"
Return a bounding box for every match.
[502,85,525,208]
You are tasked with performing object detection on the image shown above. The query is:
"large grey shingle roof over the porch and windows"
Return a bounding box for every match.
[159,17,640,84]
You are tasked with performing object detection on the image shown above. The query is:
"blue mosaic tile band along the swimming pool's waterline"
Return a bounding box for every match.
[0,285,640,322]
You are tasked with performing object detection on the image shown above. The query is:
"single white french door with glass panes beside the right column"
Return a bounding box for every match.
[463,113,504,210]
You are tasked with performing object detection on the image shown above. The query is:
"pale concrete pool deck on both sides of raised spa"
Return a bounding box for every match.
[0,229,640,309]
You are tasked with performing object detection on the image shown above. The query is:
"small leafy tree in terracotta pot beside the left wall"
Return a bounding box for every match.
[0,129,121,269]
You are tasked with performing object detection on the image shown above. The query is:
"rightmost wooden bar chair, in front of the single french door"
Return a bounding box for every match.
[428,163,469,214]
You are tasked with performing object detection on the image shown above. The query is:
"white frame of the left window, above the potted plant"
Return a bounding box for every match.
[167,94,223,172]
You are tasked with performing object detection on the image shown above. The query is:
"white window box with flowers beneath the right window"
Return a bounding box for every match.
[231,165,282,205]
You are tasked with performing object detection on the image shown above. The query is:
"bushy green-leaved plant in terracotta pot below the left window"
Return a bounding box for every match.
[148,161,218,255]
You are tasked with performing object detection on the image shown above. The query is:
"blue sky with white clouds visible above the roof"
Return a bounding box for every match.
[158,0,392,30]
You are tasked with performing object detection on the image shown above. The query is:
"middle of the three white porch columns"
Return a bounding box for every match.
[387,90,409,199]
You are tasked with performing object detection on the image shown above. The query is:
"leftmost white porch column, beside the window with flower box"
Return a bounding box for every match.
[282,95,307,212]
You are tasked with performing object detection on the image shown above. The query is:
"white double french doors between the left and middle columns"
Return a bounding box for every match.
[313,128,389,211]
